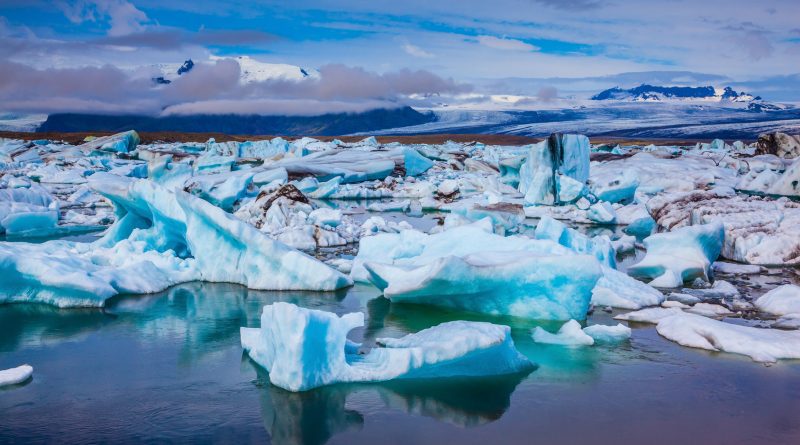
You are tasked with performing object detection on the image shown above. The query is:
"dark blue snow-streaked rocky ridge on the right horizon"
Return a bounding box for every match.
[591,84,761,103]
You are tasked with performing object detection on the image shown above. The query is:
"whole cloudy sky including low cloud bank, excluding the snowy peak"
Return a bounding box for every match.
[0,0,800,112]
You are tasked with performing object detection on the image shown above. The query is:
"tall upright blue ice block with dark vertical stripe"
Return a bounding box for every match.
[516,133,590,205]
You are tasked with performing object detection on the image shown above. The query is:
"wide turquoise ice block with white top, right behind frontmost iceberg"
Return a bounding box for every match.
[363,250,601,320]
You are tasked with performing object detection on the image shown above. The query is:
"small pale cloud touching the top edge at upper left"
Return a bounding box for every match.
[55,0,149,36]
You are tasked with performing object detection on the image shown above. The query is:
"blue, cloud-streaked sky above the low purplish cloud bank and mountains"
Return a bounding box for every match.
[0,0,800,113]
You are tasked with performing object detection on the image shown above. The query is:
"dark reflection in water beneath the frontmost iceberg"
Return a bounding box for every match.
[253,356,528,445]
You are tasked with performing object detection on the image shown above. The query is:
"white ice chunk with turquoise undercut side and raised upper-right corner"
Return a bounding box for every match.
[628,223,725,288]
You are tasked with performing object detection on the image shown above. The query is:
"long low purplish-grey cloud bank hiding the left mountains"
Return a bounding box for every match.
[0,59,471,115]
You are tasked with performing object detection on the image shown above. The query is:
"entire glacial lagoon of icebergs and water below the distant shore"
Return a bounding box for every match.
[0,133,800,443]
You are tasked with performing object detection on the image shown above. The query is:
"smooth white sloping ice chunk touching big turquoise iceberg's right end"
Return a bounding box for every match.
[592,266,664,309]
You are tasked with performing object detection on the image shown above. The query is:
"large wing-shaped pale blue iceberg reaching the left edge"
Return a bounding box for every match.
[0,173,352,307]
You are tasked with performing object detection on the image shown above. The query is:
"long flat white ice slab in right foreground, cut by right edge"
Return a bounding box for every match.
[656,314,800,363]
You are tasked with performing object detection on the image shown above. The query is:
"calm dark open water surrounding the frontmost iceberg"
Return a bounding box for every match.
[0,283,800,445]
